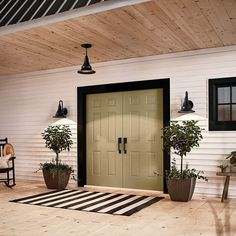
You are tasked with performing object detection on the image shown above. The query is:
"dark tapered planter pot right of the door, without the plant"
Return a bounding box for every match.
[167,178,196,202]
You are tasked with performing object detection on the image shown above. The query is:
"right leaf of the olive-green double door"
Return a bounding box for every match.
[123,89,163,190]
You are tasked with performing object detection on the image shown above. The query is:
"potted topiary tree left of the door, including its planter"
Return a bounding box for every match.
[39,125,73,189]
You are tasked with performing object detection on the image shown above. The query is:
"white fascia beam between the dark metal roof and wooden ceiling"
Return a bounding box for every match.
[0,0,151,36]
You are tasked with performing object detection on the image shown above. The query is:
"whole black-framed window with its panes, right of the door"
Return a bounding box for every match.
[209,77,236,131]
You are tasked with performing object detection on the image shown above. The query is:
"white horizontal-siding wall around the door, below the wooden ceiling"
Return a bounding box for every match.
[0,46,236,197]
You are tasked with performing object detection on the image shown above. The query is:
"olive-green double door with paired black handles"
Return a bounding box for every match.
[86,89,163,190]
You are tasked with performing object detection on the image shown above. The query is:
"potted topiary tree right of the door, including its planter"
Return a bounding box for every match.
[162,120,207,202]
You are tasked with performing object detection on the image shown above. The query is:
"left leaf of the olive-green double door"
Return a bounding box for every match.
[87,93,122,187]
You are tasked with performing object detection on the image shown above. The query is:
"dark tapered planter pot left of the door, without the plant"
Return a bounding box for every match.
[43,170,70,190]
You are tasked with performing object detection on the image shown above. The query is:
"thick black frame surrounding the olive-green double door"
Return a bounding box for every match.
[77,79,170,193]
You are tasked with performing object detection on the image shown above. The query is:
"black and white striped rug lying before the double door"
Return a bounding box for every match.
[11,189,163,216]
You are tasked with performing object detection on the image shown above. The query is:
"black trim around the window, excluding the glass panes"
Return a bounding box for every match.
[208,77,236,131]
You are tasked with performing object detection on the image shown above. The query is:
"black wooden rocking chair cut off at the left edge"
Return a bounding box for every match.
[0,138,16,188]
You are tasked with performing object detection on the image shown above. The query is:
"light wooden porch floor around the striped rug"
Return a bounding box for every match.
[0,182,236,236]
